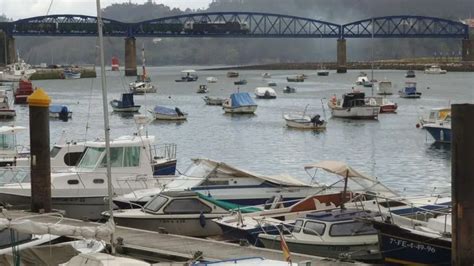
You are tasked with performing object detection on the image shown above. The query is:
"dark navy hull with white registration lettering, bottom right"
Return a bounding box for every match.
[372,222,451,265]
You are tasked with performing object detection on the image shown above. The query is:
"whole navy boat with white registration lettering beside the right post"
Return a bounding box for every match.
[368,214,452,265]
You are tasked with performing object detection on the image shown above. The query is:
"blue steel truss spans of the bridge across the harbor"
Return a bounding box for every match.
[0,12,469,39]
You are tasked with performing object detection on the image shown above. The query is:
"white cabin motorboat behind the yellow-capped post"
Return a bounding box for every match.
[0,134,176,220]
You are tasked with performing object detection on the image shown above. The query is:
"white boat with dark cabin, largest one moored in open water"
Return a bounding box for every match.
[328,92,380,119]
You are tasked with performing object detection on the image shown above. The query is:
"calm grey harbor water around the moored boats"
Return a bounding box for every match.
[9,66,474,194]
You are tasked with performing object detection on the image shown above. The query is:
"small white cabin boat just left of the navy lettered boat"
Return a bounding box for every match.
[258,209,382,262]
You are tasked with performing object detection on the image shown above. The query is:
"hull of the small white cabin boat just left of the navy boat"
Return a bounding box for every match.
[259,235,382,262]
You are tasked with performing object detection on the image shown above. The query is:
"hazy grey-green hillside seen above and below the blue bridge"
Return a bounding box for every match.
[11,0,474,65]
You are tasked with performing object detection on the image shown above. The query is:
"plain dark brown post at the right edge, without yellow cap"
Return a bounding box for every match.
[451,104,474,265]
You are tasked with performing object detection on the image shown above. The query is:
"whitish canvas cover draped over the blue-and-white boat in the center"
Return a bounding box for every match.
[166,158,310,190]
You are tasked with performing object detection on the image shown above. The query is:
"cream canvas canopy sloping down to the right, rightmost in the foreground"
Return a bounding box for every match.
[304,161,398,197]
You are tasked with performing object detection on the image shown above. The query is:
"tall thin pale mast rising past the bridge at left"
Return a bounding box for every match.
[96,0,115,254]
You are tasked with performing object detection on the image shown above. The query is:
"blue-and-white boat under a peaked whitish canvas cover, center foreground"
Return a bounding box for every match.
[114,158,326,209]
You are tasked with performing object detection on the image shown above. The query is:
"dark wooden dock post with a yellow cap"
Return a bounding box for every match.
[28,88,51,212]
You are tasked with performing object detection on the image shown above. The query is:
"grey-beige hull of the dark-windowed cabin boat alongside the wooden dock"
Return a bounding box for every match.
[114,214,222,237]
